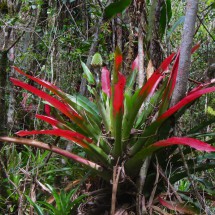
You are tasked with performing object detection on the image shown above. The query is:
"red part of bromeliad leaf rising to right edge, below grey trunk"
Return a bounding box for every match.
[157,87,215,121]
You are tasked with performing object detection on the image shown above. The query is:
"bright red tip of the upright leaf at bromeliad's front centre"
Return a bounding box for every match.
[113,73,126,114]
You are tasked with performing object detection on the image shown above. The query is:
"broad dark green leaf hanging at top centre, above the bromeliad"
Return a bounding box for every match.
[104,0,132,19]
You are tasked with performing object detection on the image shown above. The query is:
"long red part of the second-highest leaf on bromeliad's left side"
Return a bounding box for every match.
[10,78,82,120]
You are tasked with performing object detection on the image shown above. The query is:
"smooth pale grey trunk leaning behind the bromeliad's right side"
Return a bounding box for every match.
[171,0,198,106]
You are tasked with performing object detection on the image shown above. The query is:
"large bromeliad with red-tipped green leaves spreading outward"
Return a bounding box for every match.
[0,45,215,213]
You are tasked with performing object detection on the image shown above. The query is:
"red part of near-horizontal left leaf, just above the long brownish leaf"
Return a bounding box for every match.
[16,129,93,148]
